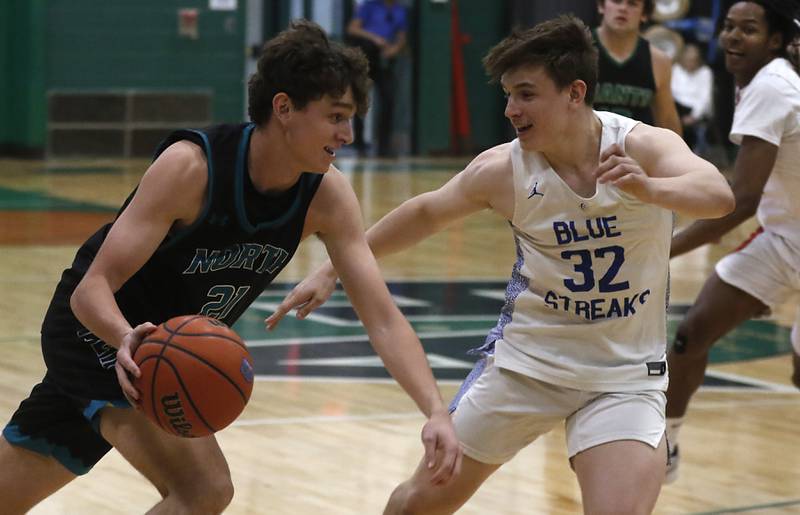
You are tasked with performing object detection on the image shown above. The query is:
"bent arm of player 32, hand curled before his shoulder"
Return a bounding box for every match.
[596,124,734,218]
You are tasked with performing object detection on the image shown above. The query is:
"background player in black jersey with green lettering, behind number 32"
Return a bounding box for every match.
[592,0,683,134]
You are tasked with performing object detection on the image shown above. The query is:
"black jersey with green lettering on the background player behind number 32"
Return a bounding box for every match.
[592,29,656,125]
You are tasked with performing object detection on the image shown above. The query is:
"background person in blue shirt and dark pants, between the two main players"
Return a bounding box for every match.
[347,0,408,157]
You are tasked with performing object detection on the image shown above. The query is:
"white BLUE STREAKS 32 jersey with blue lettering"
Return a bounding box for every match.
[487,112,672,392]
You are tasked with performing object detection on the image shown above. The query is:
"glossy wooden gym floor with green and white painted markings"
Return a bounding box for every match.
[0,155,800,515]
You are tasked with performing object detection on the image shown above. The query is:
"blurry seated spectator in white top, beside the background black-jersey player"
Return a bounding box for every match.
[671,43,714,153]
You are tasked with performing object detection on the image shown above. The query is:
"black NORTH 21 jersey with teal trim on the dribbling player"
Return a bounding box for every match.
[42,124,323,399]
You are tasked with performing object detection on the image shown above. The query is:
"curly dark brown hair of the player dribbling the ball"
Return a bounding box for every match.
[247,20,371,126]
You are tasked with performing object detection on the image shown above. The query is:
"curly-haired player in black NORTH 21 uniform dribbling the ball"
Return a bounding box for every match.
[0,22,461,513]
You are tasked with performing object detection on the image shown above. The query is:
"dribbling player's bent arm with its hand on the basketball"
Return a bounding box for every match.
[70,142,207,400]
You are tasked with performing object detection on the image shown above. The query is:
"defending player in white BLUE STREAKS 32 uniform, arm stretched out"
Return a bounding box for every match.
[267,16,733,514]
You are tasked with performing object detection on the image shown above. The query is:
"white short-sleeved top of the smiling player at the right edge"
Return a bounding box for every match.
[730,58,800,252]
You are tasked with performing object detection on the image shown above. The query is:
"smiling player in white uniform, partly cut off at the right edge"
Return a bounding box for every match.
[666,0,800,482]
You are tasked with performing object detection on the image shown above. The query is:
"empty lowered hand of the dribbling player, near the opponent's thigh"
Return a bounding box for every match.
[422,410,462,485]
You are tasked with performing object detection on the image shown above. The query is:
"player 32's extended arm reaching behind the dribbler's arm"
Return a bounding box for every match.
[264,145,506,329]
